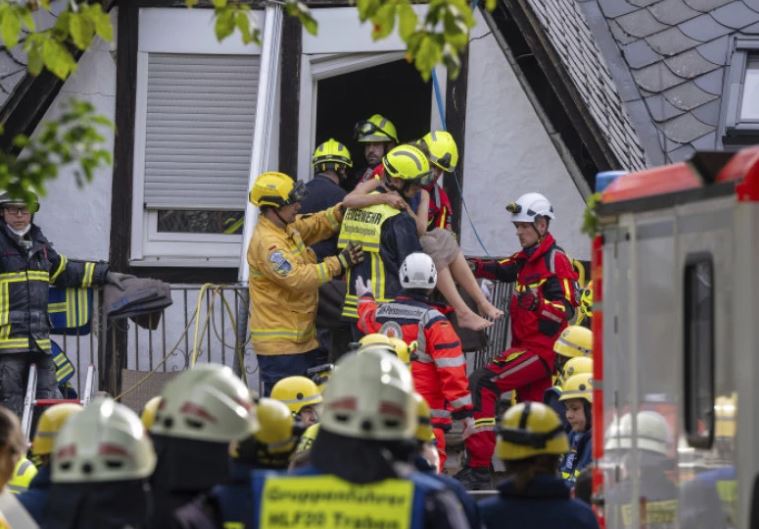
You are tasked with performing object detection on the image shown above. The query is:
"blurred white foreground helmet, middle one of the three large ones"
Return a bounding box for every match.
[150,364,258,443]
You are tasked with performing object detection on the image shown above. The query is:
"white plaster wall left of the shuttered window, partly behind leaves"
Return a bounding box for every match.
[35,23,116,260]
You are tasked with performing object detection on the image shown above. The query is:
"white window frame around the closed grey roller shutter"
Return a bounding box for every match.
[129,8,264,268]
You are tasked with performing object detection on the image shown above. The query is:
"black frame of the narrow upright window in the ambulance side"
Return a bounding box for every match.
[682,252,716,449]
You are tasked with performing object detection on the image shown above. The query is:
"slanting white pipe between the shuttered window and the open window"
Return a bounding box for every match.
[238,5,283,282]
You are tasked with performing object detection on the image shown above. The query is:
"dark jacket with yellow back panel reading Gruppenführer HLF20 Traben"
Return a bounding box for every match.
[253,462,468,529]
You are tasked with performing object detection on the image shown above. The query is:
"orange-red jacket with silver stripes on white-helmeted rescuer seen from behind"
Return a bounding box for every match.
[358,293,472,430]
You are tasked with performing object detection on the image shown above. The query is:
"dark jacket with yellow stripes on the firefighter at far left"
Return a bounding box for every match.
[0,222,108,354]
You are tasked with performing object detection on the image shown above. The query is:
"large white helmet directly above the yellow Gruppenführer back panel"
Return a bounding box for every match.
[320,348,417,441]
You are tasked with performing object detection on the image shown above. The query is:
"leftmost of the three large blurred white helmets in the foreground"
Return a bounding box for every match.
[52,397,156,483]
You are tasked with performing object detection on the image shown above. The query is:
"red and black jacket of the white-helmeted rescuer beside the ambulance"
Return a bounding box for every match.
[474,233,577,364]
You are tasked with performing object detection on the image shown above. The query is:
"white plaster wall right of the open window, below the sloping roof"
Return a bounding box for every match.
[461,13,590,259]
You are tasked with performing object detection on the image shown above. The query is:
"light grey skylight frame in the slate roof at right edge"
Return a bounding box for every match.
[723,37,759,143]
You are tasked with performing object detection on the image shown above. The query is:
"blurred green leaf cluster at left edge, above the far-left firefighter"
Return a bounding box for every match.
[0,99,112,207]
